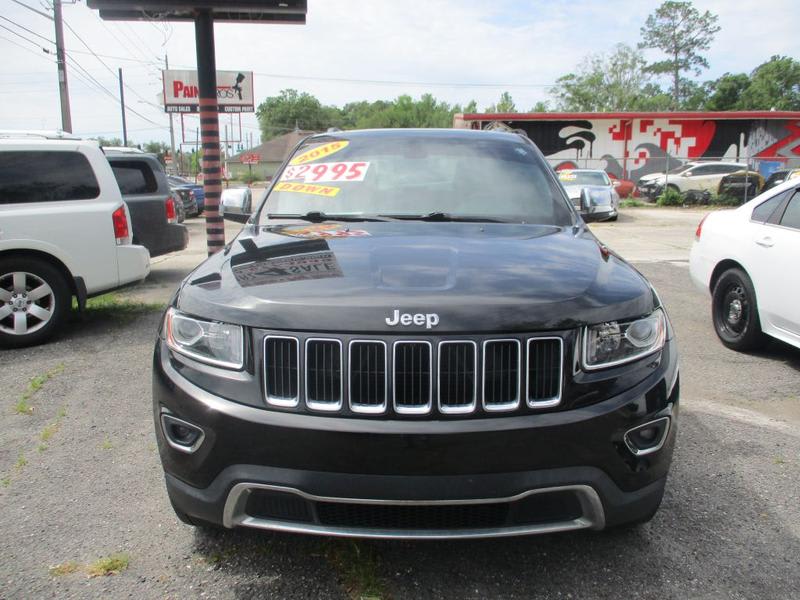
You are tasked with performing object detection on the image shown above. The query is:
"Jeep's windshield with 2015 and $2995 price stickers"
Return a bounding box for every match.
[261,134,572,226]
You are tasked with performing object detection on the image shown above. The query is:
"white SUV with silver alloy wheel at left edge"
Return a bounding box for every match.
[0,132,150,347]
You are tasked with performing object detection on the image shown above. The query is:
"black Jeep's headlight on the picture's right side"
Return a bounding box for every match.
[583,308,667,371]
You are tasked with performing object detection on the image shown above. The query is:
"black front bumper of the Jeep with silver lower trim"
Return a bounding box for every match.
[153,341,679,538]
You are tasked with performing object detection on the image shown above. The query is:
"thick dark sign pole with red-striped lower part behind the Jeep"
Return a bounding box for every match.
[194,10,225,256]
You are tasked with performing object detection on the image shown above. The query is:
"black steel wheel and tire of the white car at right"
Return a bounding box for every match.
[711,268,766,352]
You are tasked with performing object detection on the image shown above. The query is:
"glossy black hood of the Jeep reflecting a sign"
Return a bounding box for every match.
[175,221,657,335]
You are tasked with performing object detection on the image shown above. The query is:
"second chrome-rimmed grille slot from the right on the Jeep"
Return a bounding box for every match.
[483,340,520,410]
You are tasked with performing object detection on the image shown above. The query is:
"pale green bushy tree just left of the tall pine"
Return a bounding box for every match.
[550,44,665,112]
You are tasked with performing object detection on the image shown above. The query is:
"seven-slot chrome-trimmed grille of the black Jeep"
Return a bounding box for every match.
[263,333,565,416]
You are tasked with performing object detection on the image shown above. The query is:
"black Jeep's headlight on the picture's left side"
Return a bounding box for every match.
[164,308,244,369]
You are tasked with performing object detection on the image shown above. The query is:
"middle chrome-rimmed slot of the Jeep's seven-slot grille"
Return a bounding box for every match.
[394,342,432,414]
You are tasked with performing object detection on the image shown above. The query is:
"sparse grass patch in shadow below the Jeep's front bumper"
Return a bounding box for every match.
[325,540,386,600]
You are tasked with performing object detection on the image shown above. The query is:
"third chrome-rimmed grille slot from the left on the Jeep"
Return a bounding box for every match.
[350,341,386,413]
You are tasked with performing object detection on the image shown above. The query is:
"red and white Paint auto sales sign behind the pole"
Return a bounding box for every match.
[162,69,255,113]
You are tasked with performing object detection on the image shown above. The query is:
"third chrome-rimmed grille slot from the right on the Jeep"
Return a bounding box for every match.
[439,342,478,413]
